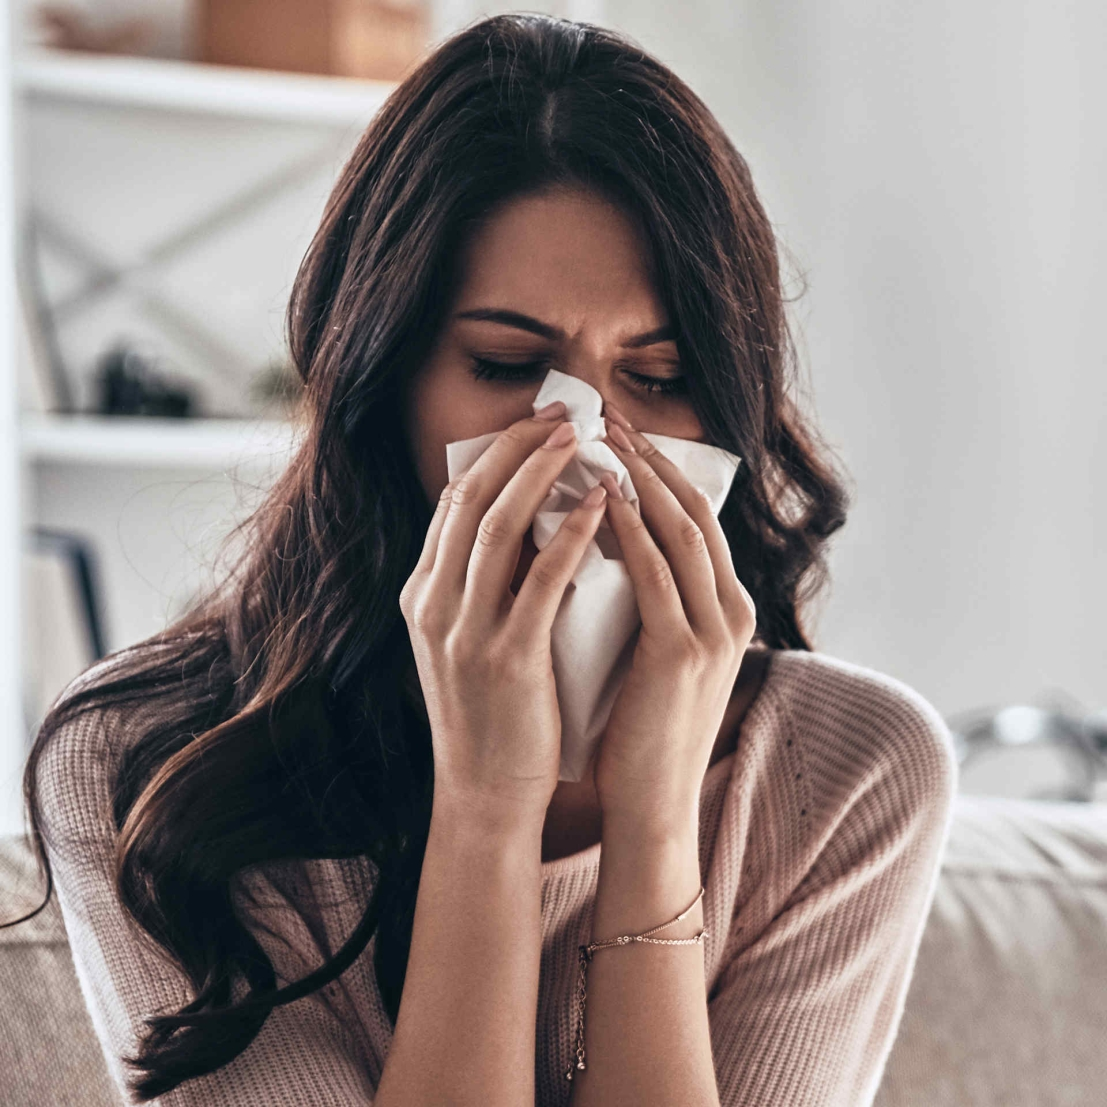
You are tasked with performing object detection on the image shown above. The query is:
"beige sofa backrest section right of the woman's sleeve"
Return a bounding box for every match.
[876,796,1107,1107]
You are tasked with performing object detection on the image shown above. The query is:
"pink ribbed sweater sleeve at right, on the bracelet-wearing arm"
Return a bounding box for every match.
[708,679,956,1107]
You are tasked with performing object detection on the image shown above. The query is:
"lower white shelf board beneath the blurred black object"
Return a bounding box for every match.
[20,413,299,469]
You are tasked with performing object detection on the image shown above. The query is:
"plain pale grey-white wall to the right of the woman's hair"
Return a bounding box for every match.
[607,0,1107,713]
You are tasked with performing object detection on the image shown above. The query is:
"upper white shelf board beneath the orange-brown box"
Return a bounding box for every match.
[14,49,395,126]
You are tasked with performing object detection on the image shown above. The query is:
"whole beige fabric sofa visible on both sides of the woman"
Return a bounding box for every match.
[0,796,1107,1107]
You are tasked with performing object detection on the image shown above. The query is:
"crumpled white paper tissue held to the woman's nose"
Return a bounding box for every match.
[446,369,741,780]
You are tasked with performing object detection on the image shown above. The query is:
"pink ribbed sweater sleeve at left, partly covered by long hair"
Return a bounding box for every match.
[38,711,373,1107]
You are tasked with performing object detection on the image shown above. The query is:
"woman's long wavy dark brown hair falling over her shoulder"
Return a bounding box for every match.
[4,15,848,1100]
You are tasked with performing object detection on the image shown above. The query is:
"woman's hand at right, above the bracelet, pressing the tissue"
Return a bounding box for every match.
[593,404,756,821]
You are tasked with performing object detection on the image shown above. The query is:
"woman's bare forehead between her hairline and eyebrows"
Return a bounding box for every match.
[457,189,668,327]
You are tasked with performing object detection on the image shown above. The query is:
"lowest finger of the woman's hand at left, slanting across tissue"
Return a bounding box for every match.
[507,485,607,642]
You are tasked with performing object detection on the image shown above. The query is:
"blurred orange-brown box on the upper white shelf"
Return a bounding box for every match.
[196,0,427,81]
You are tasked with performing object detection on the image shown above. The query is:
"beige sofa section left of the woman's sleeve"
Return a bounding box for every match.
[0,838,120,1107]
